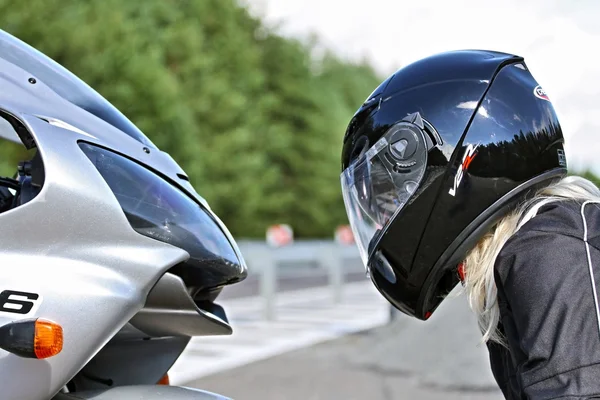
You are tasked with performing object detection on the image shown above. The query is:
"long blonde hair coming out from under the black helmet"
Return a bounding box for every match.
[464,176,600,345]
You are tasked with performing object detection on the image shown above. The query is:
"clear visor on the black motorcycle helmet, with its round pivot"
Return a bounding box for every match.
[341,118,428,267]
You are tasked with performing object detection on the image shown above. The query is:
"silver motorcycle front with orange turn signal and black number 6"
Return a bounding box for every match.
[0,31,247,400]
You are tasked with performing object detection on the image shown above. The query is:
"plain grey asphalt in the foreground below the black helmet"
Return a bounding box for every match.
[190,290,503,400]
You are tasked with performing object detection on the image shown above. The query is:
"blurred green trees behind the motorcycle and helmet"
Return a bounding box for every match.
[0,0,598,237]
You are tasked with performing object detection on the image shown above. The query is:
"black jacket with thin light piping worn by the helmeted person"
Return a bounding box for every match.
[488,201,600,400]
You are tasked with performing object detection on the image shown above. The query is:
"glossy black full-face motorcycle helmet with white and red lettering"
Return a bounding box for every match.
[341,51,566,320]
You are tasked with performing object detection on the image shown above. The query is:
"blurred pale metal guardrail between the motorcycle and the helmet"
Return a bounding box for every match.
[238,240,363,321]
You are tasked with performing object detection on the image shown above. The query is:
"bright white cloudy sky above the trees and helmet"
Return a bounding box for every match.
[244,0,600,174]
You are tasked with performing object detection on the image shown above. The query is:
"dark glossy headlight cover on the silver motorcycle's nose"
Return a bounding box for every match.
[80,143,246,286]
